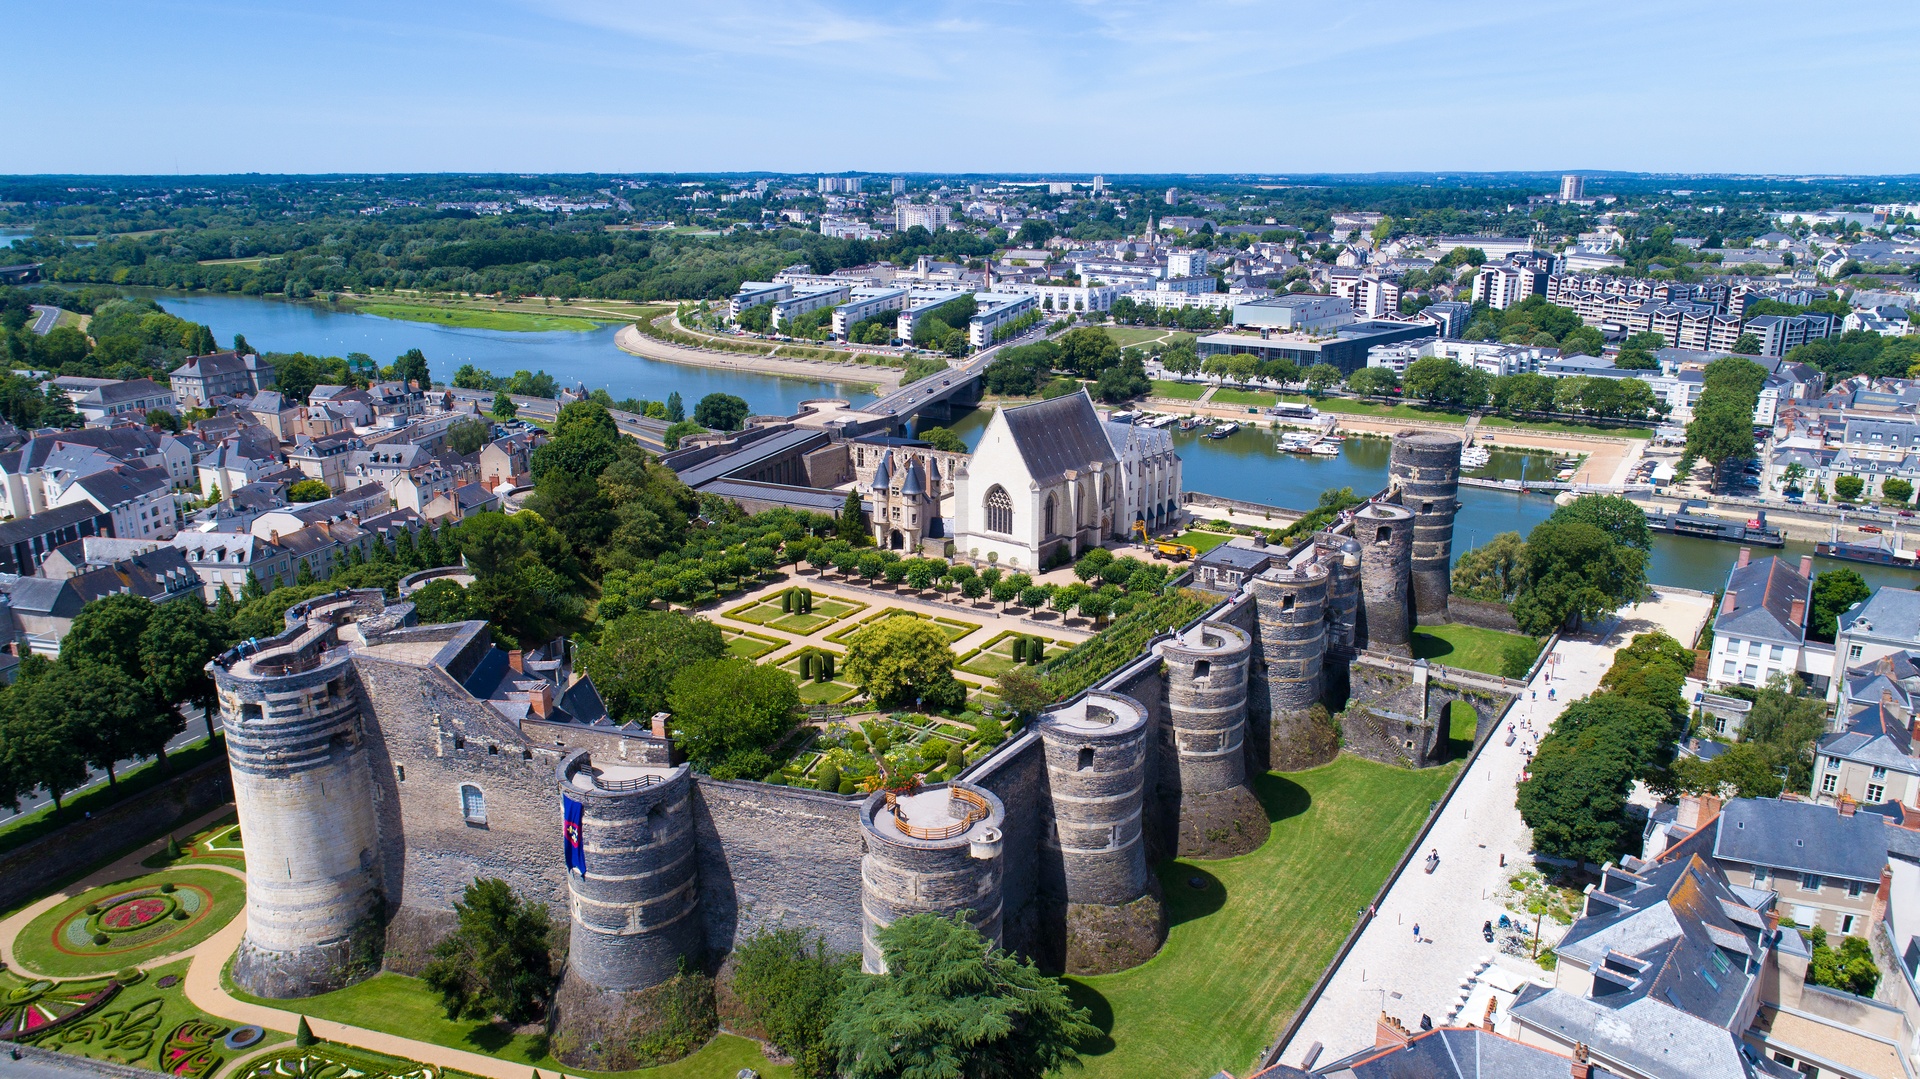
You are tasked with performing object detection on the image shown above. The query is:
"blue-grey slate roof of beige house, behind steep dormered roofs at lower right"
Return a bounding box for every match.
[1713,799,1887,881]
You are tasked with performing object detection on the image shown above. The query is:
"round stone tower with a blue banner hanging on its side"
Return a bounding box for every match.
[557,749,703,991]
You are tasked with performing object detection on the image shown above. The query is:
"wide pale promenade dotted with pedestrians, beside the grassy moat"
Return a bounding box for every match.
[1281,593,1713,1066]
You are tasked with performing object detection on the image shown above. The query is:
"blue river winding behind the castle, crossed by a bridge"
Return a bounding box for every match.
[97,292,1920,591]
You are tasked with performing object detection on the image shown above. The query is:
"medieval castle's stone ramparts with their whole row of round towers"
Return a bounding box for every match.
[213,424,1515,1052]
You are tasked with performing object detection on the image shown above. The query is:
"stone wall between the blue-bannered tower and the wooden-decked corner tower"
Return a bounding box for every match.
[691,776,862,956]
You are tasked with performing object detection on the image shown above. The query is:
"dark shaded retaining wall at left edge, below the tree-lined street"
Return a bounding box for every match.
[0,756,234,910]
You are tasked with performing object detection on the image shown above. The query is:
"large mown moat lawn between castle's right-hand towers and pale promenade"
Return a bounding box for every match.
[1068,756,1457,1079]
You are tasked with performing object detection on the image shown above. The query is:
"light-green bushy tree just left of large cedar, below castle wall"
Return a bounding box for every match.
[733,925,860,1079]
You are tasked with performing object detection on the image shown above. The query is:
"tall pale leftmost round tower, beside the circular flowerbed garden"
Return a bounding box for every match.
[211,618,382,1000]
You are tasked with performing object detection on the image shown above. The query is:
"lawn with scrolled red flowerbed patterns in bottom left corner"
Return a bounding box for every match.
[13,960,290,1073]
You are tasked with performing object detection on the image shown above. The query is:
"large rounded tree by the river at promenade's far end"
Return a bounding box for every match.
[1511,520,1647,637]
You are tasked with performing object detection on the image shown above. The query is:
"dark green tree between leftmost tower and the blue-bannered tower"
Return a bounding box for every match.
[420,877,555,1025]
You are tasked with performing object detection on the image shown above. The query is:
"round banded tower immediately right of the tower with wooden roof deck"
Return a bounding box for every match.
[1039,689,1165,973]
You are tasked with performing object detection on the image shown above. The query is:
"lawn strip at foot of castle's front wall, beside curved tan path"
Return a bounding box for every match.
[228,973,793,1079]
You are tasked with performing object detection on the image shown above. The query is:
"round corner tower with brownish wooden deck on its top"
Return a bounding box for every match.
[860,781,1006,973]
